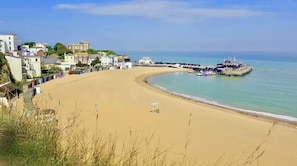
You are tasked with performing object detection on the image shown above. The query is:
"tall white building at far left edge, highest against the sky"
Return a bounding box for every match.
[0,34,21,53]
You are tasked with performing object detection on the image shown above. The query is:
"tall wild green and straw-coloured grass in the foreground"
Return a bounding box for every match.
[0,105,191,166]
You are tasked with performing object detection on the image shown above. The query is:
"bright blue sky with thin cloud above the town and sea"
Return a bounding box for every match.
[0,0,297,52]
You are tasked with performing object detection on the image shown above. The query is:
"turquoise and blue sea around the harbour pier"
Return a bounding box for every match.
[118,51,297,122]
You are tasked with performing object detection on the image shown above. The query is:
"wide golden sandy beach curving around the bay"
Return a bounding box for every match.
[33,67,297,165]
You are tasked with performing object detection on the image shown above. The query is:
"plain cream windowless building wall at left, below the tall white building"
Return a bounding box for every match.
[5,55,23,81]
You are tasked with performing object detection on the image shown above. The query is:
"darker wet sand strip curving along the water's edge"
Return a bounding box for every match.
[135,67,297,128]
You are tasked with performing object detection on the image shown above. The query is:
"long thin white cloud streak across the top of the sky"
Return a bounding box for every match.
[55,0,262,23]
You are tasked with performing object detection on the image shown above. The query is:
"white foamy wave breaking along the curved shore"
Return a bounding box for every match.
[148,82,297,122]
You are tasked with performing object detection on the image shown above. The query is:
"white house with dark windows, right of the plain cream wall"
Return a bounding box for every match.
[23,56,41,78]
